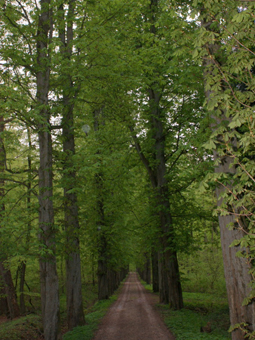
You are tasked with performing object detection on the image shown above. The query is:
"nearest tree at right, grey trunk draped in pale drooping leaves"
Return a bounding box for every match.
[193,2,255,340]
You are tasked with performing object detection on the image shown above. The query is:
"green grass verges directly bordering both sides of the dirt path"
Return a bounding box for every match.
[63,282,231,340]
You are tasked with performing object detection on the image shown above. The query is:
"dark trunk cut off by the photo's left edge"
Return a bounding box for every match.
[0,116,20,319]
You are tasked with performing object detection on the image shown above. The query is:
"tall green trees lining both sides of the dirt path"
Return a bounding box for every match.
[0,0,255,340]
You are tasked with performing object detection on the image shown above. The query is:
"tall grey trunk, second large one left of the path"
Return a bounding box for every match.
[59,0,85,330]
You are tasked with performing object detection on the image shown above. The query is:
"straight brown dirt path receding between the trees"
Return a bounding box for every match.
[94,273,175,340]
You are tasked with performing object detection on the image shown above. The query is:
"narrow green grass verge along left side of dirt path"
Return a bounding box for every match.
[63,295,117,340]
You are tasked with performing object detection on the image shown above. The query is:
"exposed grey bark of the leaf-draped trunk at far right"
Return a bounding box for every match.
[214,152,255,340]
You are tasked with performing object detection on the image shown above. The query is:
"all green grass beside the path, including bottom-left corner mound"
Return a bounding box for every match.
[0,276,230,340]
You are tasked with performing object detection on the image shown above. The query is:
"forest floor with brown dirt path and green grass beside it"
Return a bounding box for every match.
[0,273,230,340]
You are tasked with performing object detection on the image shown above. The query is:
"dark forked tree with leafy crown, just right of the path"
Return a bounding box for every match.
[122,1,202,309]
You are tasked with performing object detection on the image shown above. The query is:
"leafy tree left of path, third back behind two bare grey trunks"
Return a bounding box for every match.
[78,106,130,300]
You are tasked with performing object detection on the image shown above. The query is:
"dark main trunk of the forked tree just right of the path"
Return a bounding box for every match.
[149,88,183,309]
